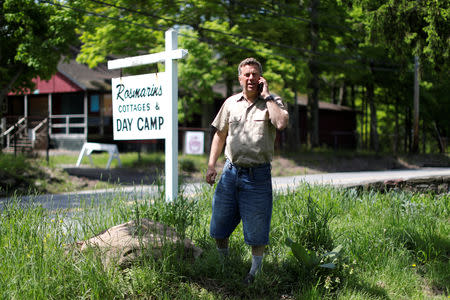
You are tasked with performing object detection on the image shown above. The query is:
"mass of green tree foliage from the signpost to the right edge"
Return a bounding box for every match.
[72,0,450,151]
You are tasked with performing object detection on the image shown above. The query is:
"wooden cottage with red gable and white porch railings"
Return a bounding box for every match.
[2,59,119,150]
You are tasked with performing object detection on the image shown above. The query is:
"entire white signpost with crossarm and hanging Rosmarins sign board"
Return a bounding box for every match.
[108,29,187,201]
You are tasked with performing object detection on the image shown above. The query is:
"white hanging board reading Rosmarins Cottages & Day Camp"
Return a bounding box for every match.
[112,73,171,140]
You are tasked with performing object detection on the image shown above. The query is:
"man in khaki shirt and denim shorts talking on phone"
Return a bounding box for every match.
[206,58,289,284]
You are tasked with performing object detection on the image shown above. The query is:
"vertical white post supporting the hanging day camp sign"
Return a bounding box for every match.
[165,29,178,201]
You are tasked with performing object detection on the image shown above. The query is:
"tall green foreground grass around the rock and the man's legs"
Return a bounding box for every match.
[0,185,450,299]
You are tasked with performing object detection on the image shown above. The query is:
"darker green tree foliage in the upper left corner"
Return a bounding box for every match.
[0,0,76,113]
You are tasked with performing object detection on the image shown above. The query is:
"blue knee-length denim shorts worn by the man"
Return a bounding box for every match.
[210,160,272,246]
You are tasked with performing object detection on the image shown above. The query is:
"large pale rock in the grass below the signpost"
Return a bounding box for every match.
[77,218,202,268]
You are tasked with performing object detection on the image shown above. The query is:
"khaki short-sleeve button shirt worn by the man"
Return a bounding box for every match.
[211,93,286,167]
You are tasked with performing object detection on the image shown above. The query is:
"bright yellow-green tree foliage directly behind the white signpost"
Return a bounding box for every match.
[77,0,230,123]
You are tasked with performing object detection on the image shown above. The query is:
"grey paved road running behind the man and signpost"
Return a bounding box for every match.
[0,168,450,209]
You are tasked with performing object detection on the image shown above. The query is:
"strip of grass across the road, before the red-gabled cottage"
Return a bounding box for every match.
[0,152,211,197]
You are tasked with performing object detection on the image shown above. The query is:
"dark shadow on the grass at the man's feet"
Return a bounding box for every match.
[155,246,389,299]
